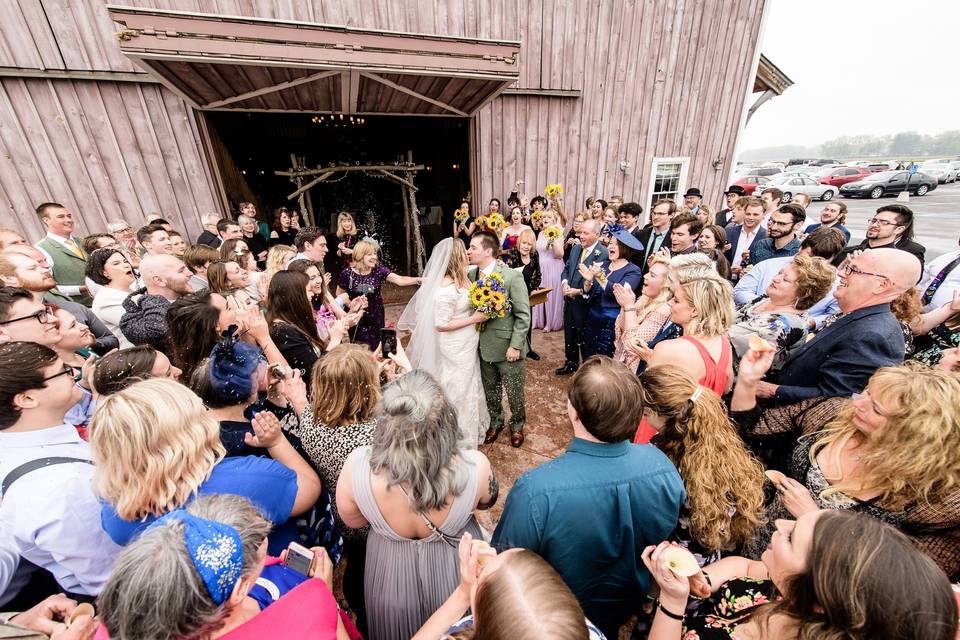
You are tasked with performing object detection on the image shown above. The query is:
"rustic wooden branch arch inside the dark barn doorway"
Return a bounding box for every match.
[274,151,426,274]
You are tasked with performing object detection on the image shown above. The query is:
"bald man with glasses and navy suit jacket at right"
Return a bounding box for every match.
[756,248,921,404]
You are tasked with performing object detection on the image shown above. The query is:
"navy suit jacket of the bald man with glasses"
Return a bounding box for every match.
[774,304,904,404]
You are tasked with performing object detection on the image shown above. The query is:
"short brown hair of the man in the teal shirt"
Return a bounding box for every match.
[567,356,643,443]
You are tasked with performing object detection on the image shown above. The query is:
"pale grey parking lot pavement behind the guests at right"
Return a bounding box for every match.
[828,182,960,261]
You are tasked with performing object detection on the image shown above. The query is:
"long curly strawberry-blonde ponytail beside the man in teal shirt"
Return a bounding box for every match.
[640,365,763,564]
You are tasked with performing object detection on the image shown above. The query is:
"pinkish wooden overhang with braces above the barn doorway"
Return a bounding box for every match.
[107,5,520,116]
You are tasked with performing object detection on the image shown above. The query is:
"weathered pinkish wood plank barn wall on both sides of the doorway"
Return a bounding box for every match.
[0,0,765,239]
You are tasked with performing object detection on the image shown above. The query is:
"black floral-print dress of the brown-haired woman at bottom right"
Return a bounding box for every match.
[680,578,781,640]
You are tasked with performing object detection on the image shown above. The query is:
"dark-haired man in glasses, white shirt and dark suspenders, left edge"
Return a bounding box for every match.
[0,342,120,597]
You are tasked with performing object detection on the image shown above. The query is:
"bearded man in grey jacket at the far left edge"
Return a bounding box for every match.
[0,244,120,355]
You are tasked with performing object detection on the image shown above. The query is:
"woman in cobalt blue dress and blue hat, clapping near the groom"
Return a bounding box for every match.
[580,230,643,360]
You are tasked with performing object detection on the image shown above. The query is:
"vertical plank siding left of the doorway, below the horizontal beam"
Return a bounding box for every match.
[0,78,219,241]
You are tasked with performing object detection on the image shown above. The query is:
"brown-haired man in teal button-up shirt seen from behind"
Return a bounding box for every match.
[493,356,686,638]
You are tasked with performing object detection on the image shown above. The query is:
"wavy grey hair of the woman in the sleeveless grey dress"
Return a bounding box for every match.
[370,369,470,513]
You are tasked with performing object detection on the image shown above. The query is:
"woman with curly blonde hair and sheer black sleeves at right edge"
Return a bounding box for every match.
[731,344,960,581]
